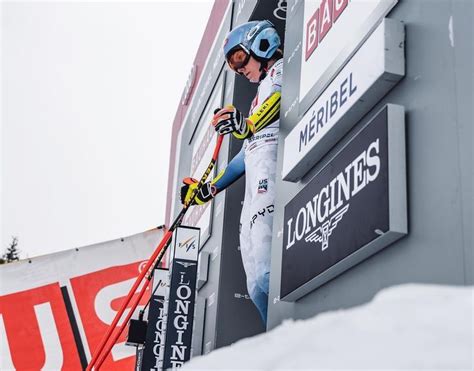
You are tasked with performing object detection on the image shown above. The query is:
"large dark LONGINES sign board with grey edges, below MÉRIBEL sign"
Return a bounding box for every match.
[280,104,407,301]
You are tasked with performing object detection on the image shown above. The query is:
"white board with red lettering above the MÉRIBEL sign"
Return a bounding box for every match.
[300,0,398,102]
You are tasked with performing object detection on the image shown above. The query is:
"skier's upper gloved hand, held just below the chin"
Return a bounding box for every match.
[212,106,253,139]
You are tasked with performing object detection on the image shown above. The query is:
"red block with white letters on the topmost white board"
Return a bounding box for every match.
[305,0,349,60]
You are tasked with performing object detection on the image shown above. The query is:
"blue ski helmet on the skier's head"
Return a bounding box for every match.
[224,20,281,61]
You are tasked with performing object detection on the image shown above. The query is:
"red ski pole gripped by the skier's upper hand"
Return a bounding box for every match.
[86,135,223,371]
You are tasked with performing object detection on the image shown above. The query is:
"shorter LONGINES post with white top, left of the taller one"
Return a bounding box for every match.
[140,268,169,371]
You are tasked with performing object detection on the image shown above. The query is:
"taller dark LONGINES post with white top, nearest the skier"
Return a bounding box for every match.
[163,227,200,370]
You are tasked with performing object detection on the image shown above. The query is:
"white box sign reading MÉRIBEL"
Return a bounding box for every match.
[282,19,405,181]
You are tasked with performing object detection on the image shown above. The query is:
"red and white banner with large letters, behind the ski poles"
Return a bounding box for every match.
[0,229,163,370]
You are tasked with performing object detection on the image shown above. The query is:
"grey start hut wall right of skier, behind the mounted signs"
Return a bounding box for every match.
[268,0,473,328]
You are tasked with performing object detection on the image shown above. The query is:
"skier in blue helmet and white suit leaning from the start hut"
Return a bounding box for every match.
[181,20,283,325]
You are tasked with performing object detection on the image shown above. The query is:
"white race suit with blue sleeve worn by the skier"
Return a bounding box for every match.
[215,59,283,323]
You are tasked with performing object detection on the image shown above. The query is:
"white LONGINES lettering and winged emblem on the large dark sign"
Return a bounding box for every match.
[286,138,381,251]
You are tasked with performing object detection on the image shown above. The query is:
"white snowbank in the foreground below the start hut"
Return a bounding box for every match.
[182,284,474,370]
